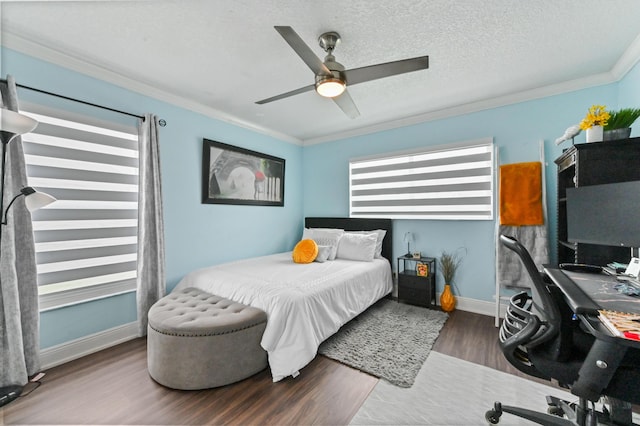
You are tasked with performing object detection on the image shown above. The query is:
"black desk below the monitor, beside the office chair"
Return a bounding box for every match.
[544,265,640,401]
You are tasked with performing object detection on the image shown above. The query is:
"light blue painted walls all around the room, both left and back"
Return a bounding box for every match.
[0,43,640,348]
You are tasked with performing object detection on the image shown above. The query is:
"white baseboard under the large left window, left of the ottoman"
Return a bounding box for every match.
[40,321,138,370]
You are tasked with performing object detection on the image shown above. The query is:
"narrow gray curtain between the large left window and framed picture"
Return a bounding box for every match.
[137,114,166,336]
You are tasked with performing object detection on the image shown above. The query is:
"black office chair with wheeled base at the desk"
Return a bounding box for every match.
[485,235,640,426]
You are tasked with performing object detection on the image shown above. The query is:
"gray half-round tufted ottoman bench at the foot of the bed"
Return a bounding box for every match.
[147,288,267,390]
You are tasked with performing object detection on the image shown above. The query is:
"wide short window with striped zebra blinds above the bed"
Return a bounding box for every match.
[349,139,494,220]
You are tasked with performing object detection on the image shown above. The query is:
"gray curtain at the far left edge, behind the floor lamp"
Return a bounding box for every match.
[0,76,40,386]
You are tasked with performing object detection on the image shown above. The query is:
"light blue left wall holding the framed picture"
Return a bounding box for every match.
[0,48,303,348]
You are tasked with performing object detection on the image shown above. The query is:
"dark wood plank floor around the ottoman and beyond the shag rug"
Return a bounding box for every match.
[0,311,544,425]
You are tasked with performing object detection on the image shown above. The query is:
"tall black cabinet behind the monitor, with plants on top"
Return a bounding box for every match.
[555,138,640,266]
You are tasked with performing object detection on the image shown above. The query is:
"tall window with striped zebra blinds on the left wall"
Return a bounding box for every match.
[22,111,138,310]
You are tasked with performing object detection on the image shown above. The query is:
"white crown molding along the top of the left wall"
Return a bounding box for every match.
[0,29,302,145]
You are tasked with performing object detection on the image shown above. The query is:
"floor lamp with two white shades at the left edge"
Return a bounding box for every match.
[0,108,56,407]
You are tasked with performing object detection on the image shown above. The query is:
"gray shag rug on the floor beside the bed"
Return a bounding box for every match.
[318,299,449,388]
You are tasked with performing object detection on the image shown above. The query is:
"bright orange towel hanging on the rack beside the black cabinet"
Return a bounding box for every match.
[500,161,544,226]
